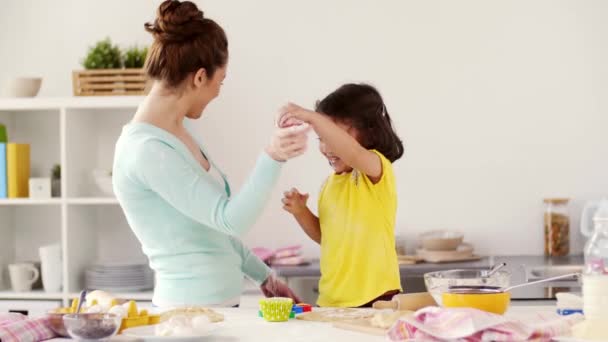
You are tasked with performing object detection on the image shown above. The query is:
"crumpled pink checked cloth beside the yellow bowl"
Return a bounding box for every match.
[388,307,584,342]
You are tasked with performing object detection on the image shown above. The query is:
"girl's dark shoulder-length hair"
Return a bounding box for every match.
[315,83,403,162]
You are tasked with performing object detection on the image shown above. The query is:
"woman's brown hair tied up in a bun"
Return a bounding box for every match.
[144,0,228,87]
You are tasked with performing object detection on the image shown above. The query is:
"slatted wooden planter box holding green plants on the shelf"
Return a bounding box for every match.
[72,69,148,96]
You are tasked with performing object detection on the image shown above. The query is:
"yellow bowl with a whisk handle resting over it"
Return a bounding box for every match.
[441,292,511,315]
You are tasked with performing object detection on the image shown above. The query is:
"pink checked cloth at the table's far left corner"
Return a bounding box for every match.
[0,313,56,342]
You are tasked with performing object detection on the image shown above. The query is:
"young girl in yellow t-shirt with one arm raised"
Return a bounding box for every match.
[280,84,403,307]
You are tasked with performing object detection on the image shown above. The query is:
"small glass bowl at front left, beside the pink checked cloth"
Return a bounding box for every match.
[63,313,121,341]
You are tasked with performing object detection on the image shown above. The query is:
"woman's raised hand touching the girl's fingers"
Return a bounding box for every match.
[266,124,310,162]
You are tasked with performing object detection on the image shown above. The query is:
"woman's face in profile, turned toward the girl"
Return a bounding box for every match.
[187,63,228,119]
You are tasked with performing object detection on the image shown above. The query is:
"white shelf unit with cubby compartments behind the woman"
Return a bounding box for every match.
[0,96,152,306]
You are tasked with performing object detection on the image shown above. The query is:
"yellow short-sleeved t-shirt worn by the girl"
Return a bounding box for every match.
[317,150,401,307]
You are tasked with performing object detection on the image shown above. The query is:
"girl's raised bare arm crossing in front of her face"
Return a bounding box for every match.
[282,104,382,183]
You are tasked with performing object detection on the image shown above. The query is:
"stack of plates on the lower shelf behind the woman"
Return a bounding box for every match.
[85,263,154,292]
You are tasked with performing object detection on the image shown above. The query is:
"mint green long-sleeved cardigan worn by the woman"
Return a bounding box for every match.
[112,123,282,306]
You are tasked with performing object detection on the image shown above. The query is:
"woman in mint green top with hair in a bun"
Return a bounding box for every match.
[113,0,307,306]
